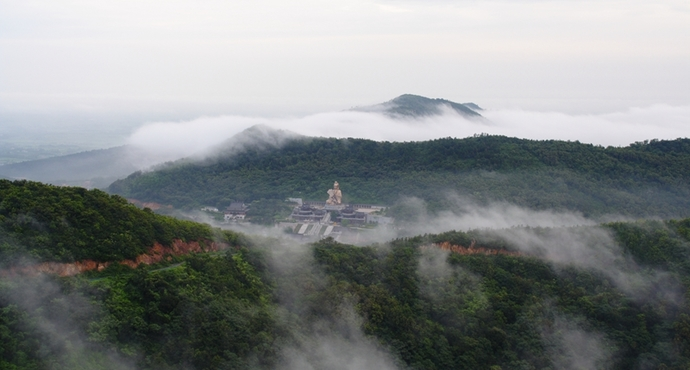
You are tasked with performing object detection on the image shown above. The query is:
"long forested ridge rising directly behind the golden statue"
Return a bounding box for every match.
[109,135,690,217]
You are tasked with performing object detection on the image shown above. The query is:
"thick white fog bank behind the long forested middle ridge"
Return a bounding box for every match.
[128,105,690,165]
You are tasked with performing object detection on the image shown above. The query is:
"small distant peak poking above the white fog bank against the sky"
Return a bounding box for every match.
[352,94,482,118]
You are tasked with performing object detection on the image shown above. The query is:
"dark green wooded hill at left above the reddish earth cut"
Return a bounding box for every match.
[0,180,212,267]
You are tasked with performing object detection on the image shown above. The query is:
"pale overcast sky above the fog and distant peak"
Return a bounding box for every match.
[0,0,690,150]
